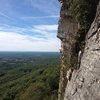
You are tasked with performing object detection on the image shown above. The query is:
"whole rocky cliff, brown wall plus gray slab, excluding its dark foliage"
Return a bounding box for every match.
[57,0,100,100]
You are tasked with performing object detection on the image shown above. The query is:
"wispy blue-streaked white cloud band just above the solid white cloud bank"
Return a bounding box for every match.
[0,24,58,38]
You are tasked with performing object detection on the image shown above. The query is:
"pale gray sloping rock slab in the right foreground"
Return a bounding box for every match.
[64,3,100,100]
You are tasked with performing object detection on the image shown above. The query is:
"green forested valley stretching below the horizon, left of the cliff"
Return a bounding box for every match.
[0,54,60,100]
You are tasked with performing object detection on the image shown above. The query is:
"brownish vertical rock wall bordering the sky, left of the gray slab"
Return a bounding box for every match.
[57,0,78,100]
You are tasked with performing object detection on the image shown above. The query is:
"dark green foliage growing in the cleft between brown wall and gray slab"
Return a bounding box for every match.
[67,0,99,52]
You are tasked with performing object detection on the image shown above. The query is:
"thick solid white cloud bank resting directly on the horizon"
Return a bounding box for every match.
[0,32,60,51]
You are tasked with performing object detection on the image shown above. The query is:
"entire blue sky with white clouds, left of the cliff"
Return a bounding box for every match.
[0,0,60,51]
